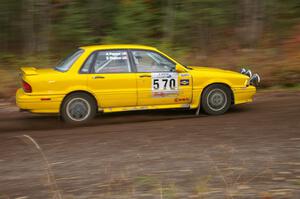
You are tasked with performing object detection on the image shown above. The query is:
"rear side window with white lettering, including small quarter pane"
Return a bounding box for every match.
[81,50,131,73]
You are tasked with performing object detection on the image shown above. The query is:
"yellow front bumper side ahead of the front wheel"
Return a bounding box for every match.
[232,86,256,104]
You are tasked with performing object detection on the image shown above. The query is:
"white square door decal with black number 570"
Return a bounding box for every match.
[151,73,178,97]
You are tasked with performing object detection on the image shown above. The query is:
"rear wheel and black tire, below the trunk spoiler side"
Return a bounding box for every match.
[60,93,97,124]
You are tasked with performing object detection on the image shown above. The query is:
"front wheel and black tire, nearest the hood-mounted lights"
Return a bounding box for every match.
[201,84,231,115]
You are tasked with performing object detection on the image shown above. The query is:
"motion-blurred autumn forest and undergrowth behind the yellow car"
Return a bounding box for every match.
[0,0,300,98]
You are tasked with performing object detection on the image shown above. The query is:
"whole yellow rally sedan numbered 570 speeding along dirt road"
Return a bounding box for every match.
[16,45,260,123]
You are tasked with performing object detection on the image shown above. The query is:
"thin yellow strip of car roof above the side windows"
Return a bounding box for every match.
[80,44,157,50]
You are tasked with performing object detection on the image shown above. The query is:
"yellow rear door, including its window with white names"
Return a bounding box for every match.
[81,50,137,108]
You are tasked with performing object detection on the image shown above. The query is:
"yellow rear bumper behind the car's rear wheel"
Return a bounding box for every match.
[16,89,63,113]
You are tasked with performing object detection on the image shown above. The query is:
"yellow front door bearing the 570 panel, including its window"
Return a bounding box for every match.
[131,50,192,106]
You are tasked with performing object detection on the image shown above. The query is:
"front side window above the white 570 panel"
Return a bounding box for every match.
[132,50,175,73]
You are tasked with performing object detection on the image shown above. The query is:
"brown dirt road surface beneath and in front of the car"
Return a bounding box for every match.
[0,91,300,199]
